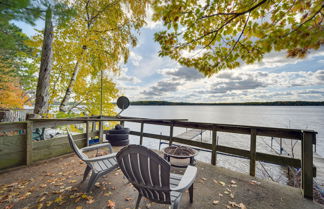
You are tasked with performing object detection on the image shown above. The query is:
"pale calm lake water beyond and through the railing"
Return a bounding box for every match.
[122,106,324,182]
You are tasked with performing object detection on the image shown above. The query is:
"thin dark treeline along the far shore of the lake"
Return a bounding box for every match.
[131,101,324,106]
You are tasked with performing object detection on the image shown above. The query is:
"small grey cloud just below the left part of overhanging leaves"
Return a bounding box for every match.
[162,67,204,81]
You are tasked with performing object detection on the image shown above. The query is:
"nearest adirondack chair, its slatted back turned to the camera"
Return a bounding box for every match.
[116,145,197,209]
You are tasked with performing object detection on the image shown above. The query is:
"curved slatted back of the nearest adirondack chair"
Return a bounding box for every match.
[116,145,171,204]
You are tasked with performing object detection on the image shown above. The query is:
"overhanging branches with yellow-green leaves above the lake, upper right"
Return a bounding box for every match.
[153,0,324,76]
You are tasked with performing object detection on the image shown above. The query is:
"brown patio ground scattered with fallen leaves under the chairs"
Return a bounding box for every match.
[0,148,324,209]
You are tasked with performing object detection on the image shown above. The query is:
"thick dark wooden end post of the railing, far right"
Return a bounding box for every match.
[302,131,316,199]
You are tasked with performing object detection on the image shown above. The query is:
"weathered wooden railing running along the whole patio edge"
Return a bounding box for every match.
[0,116,317,199]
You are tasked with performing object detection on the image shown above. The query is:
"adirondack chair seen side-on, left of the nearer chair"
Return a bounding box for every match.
[67,130,118,192]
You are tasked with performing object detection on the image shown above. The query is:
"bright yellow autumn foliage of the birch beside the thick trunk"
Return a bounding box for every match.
[30,0,146,116]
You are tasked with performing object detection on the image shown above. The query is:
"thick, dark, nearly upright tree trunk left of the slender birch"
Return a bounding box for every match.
[34,7,53,114]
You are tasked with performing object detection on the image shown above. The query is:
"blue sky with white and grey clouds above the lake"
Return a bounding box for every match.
[16,14,324,103]
